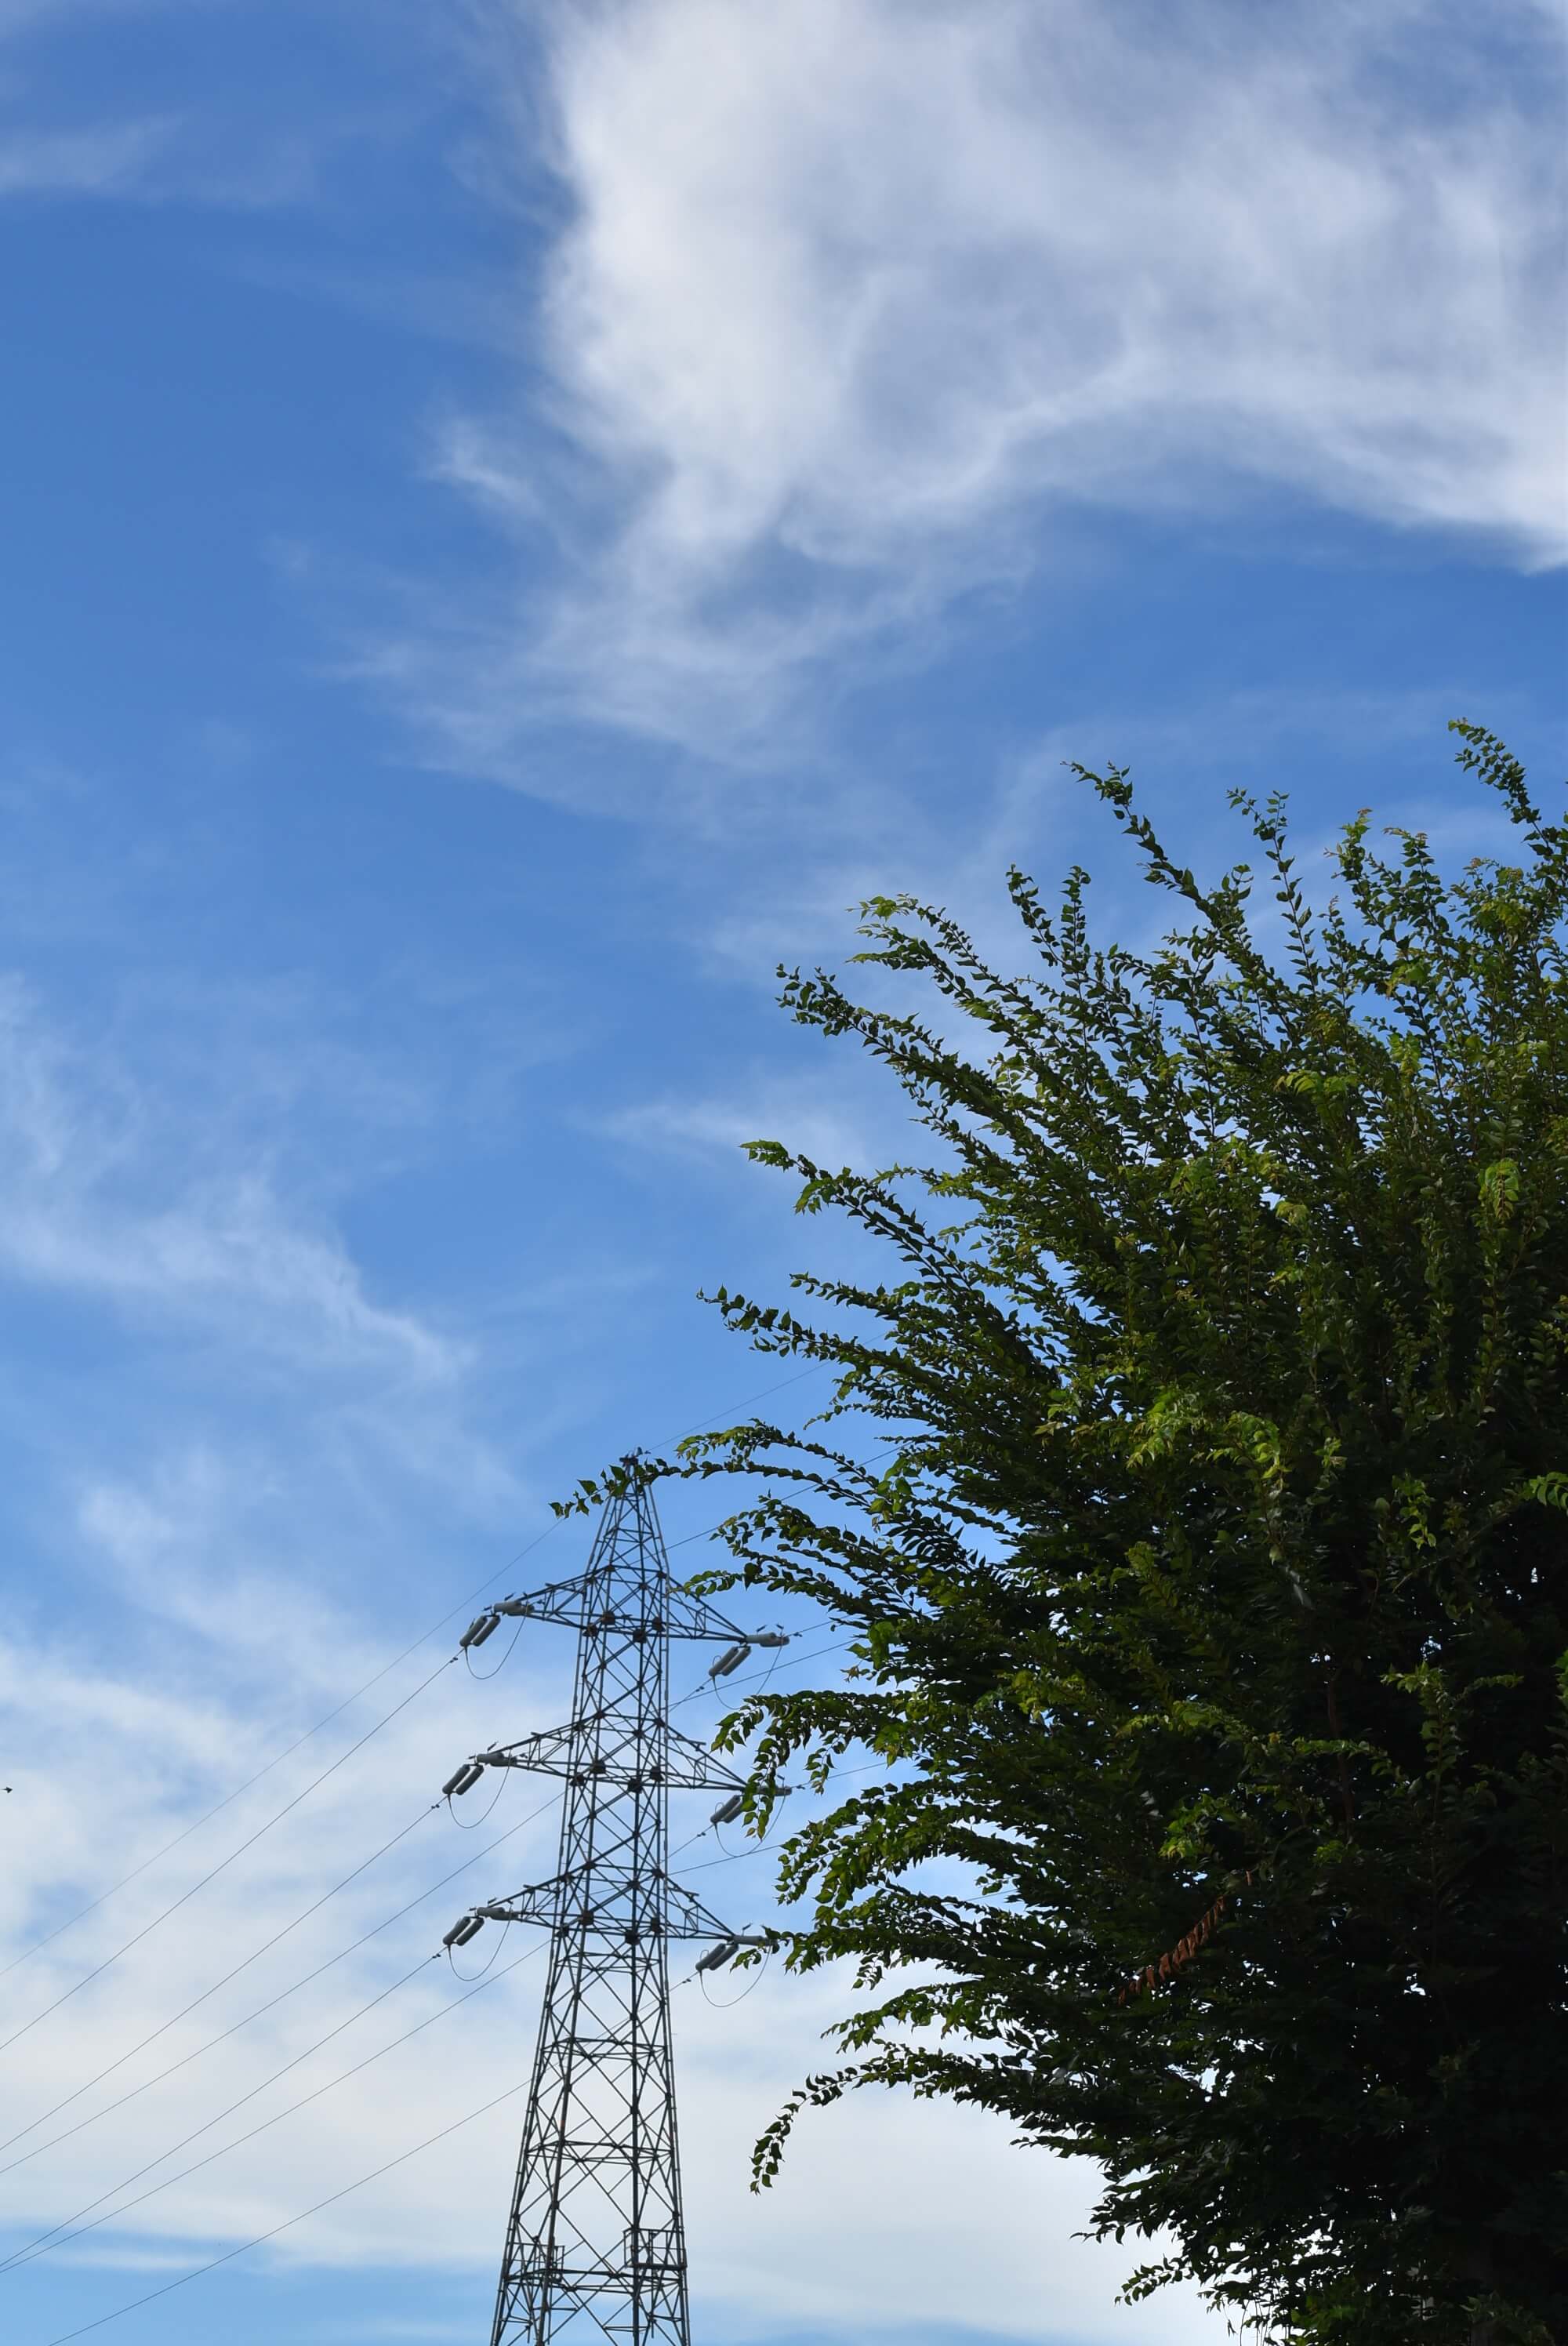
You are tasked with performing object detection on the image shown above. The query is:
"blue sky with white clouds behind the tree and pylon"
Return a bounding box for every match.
[0,0,1568,2346]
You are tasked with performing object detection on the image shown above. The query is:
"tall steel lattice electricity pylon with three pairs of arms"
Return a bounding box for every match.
[444,1459,786,2346]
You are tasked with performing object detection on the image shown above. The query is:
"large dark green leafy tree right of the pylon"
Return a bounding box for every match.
[619,725,1568,2346]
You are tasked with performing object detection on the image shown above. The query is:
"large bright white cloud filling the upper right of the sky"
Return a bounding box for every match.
[424,0,1568,772]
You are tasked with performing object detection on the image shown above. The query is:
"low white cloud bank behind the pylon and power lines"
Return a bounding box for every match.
[0,1567,1221,2346]
